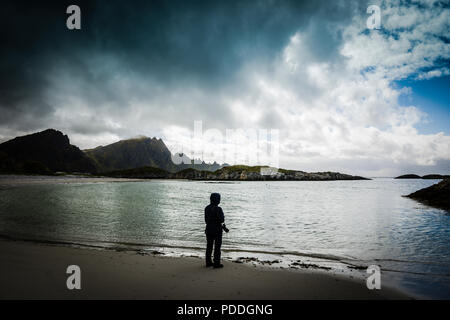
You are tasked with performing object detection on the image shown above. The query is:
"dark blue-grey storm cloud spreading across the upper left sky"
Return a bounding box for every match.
[0,0,358,133]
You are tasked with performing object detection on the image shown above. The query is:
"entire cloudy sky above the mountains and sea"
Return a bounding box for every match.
[0,0,450,177]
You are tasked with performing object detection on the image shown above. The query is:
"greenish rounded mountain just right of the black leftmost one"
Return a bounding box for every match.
[84,137,222,172]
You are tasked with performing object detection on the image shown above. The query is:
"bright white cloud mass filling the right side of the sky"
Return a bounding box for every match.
[163,2,450,175]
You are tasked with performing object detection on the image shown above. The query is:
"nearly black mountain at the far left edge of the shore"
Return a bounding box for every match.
[0,129,97,174]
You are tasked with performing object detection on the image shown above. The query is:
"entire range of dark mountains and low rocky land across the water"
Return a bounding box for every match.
[0,129,370,181]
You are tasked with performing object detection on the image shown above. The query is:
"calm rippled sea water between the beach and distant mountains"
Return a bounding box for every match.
[0,179,450,298]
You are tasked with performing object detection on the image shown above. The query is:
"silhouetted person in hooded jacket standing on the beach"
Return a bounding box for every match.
[205,193,228,268]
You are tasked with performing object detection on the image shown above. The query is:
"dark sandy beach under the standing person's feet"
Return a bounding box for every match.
[0,240,408,299]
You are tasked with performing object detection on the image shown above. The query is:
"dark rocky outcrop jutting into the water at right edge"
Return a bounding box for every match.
[407,178,450,211]
